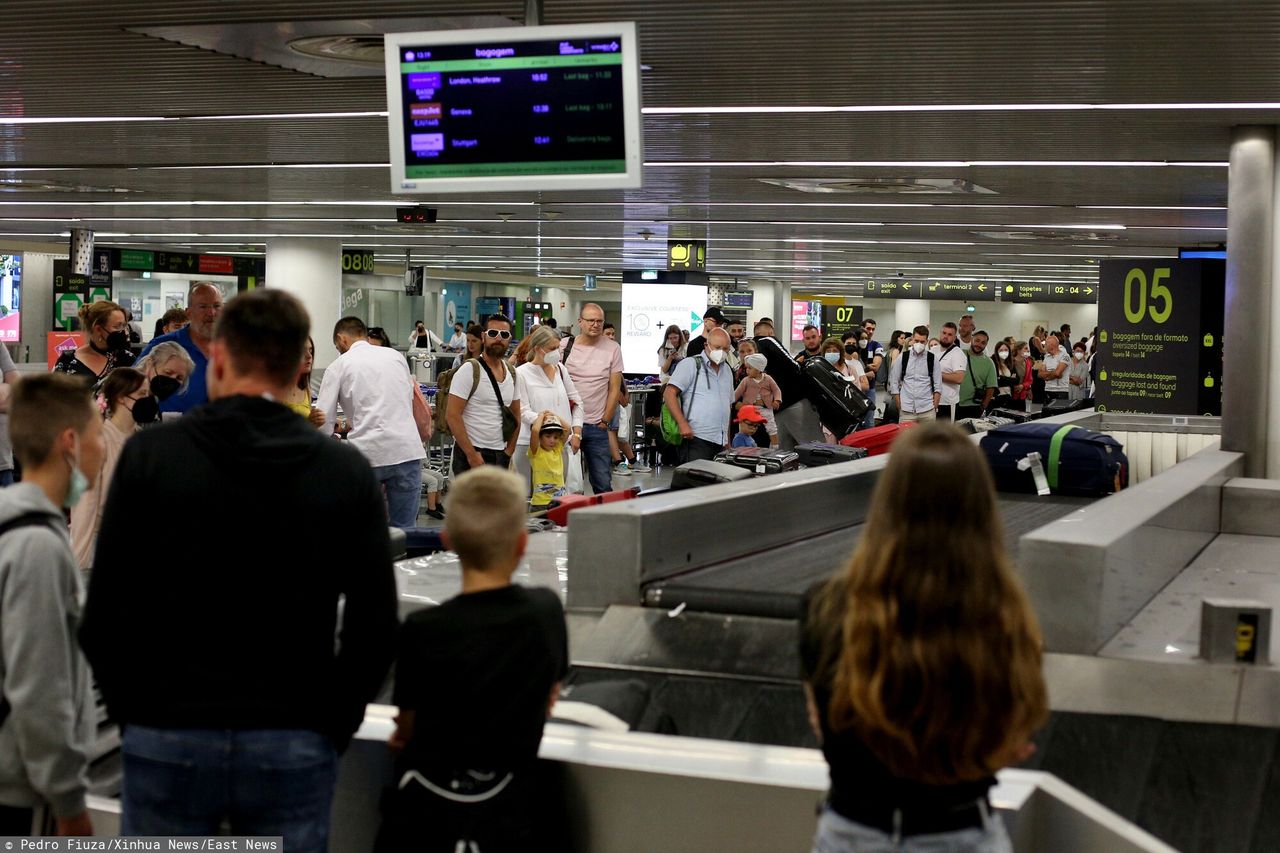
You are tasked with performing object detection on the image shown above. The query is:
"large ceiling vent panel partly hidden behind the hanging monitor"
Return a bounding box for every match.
[129,15,517,77]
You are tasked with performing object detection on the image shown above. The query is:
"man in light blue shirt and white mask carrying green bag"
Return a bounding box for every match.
[663,329,736,462]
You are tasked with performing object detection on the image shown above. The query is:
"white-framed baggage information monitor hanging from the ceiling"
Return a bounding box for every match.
[385,22,644,193]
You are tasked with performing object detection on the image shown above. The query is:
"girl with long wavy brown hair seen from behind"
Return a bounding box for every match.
[801,424,1048,853]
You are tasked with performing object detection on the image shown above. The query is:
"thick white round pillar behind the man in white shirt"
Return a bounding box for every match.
[266,237,342,368]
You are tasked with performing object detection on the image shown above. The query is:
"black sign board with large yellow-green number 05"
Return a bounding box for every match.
[1094,259,1226,415]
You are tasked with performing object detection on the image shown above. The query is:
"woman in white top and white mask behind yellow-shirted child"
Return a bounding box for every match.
[513,325,582,499]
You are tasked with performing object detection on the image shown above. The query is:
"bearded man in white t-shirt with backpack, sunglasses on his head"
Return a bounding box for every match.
[436,314,520,475]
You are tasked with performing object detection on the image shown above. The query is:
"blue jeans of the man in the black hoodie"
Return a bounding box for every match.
[120,725,338,853]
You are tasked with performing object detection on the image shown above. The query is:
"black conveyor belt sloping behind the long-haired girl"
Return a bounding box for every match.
[644,494,1093,619]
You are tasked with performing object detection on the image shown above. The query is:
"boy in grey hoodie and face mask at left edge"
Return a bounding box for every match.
[0,373,102,835]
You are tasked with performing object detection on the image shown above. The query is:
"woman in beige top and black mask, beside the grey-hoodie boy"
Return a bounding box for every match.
[72,368,147,569]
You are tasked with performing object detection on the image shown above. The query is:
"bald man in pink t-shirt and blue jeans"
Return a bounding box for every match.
[561,302,622,494]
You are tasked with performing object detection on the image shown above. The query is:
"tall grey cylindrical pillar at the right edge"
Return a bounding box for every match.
[1222,127,1280,478]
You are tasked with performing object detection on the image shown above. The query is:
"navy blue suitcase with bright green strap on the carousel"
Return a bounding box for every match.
[978,423,1129,497]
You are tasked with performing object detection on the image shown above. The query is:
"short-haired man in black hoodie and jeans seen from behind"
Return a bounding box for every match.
[79,289,397,853]
